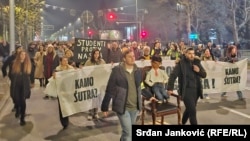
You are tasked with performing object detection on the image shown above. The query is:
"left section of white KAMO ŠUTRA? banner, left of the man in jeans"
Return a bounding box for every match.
[56,64,112,117]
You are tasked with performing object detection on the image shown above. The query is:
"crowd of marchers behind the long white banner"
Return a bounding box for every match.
[0,39,245,96]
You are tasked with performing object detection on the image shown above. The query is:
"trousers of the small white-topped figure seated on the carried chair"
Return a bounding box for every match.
[152,83,169,100]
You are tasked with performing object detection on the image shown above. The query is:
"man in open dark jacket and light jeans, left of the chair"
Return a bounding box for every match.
[101,50,142,141]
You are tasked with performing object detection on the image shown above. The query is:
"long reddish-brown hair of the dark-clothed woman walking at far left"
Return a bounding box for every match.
[12,51,31,74]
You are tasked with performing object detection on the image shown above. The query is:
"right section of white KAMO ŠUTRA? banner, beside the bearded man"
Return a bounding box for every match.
[202,59,247,94]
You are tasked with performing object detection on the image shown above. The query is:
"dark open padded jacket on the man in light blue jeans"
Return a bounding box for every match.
[101,63,142,114]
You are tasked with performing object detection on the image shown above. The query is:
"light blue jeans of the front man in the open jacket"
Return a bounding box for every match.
[117,110,139,141]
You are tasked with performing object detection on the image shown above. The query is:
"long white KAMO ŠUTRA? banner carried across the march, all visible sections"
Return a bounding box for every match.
[50,59,247,117]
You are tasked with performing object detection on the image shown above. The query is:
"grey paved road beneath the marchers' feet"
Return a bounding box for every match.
[0,71,250,141]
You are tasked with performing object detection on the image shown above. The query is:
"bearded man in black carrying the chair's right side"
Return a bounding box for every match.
[167,48,207,125]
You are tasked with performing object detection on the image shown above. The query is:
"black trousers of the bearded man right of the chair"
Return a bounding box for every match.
[182,88,198,125]
